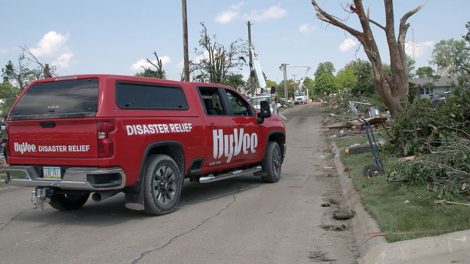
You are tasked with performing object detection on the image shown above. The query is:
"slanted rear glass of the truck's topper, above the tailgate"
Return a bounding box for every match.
[10,78,98,120]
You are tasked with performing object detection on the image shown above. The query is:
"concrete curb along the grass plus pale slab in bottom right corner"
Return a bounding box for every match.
[331,142,470,264]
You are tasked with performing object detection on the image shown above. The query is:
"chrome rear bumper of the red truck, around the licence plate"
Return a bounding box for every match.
[5,166,126,191]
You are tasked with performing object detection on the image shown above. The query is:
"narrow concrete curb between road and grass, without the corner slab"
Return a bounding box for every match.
[331,142,387,263]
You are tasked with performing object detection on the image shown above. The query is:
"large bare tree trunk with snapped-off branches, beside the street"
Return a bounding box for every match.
[312,0,423,117]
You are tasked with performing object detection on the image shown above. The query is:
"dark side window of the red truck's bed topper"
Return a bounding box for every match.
[116,82,188,110]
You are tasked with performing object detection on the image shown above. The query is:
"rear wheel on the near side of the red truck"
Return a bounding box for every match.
[144,155,183,215]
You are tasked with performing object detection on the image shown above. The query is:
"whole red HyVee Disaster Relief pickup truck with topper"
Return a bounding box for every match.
[6,75,286,215]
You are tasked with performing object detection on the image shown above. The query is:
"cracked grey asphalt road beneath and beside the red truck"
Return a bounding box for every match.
[0,104,356,264]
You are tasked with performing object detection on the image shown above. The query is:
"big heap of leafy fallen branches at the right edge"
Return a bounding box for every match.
[387,89,470,199]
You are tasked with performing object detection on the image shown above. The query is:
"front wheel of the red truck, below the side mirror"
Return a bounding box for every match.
[261,141,282,182]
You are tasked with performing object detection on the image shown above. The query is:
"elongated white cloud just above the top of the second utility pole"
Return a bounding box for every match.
[215,1,287,24]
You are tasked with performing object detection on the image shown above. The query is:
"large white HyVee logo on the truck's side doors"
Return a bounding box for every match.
[212,128,258,163]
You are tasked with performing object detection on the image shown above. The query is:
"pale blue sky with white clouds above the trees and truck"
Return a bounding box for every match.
[0,0,470,82]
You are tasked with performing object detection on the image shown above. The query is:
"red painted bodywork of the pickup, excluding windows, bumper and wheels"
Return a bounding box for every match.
[7,75,285,187]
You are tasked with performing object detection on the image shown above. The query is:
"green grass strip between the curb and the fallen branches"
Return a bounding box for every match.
[336,135,470,242]
